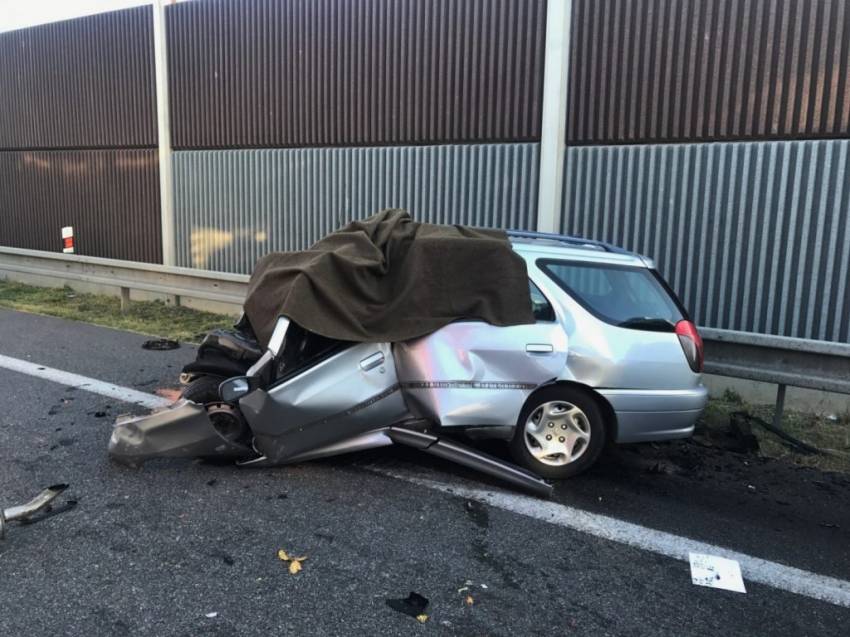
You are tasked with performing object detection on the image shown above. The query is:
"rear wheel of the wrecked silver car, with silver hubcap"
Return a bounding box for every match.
[511,386,606,480]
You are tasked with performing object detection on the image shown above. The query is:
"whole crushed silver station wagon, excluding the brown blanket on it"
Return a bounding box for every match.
[109,214,707,495]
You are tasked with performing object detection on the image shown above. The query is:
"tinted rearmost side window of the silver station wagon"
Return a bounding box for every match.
[537,259,686,331]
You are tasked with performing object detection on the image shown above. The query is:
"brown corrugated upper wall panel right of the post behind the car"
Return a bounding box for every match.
[567,0,850,144]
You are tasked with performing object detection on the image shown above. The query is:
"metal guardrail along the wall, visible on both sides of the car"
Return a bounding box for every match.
[0,248,850,417]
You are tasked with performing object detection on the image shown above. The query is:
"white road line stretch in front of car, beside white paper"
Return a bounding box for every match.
[372,465,850,608]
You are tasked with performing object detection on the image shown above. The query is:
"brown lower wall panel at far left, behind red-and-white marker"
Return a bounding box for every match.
[0,149,162,263]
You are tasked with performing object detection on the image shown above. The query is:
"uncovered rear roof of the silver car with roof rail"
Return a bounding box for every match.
[508,231,654,268]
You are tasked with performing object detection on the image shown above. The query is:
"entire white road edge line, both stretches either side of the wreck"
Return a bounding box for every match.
[0,354,850,608]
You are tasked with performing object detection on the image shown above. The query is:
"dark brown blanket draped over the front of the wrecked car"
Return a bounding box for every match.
[245,210,534,346]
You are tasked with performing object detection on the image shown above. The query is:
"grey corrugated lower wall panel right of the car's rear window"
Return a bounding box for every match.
[561,140,850,342]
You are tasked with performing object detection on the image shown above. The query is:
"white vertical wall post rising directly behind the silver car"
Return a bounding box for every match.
[537,0,573,232]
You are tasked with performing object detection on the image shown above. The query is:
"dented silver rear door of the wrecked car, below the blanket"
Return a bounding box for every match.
[393,321,567,427]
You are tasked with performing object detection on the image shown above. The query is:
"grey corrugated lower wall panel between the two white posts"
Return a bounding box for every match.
[173,143,539,272]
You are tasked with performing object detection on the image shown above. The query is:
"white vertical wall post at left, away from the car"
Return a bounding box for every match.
[153,0,177,265]
